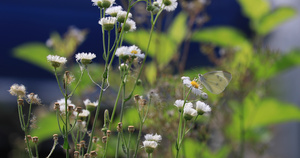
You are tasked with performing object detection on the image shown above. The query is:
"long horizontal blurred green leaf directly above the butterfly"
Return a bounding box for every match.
[191,26,250,47]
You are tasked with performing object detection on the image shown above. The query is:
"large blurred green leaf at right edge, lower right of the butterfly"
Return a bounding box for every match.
[226,94,300,140]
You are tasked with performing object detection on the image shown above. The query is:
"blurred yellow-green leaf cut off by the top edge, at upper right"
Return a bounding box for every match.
[239,0,270,22]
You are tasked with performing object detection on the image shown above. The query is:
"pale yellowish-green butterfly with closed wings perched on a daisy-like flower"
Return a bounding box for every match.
[199,71,232,94]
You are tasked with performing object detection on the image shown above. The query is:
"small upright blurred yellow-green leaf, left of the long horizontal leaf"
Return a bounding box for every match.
[168,12,187,45]
